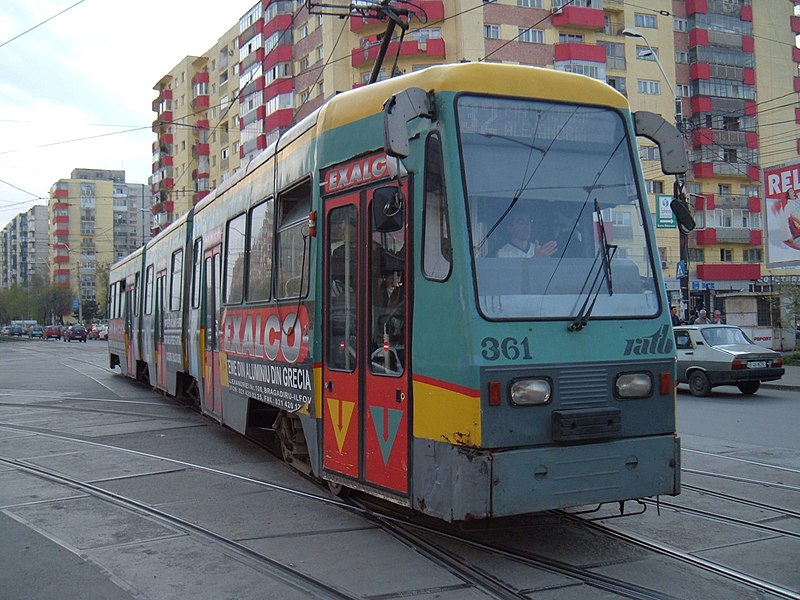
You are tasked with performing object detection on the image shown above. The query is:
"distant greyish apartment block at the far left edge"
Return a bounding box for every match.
[0,205,50,288]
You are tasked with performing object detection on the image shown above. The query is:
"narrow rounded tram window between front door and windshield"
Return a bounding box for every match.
[422,134,453,281]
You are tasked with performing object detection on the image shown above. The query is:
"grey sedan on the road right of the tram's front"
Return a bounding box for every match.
[673,325,784,396]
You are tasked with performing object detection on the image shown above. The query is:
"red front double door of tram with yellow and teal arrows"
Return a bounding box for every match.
[322,189,410,495]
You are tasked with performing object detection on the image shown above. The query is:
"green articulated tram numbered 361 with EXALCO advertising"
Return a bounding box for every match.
[109,63,686,521]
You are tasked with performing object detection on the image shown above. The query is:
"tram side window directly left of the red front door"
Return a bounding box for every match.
[276,181,311,298]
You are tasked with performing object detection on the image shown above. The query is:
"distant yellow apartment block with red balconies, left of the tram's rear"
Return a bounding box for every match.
[47,169,152,304]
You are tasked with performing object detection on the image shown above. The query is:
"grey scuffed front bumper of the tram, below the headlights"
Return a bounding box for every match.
[413,435,680,521]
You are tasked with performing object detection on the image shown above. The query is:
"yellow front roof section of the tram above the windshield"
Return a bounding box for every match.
[317,63,629,131]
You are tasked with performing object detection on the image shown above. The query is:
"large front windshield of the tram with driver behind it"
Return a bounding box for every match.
[457,96,659,324]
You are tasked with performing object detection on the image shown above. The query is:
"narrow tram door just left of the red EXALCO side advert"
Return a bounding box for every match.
[201,246,222,421]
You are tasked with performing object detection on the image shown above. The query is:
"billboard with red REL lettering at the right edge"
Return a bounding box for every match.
[764,163,800,267]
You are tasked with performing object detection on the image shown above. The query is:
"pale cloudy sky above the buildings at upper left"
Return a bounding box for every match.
[0,0,256,228]
